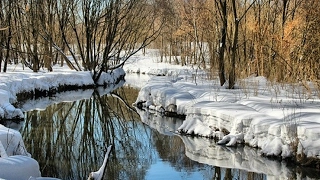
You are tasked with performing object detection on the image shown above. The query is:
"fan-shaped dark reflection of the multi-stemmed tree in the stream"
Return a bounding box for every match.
[21,87,155,179]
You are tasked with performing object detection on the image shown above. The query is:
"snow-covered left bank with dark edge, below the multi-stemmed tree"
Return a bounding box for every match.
[0,69,125,119]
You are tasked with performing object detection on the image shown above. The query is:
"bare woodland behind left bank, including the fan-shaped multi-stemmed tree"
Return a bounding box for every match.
[0,0,162,83]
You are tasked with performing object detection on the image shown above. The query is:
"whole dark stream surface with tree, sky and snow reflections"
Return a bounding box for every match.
[12,83,320,180]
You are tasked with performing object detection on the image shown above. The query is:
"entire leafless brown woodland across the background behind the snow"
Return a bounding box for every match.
[0,0,320,88]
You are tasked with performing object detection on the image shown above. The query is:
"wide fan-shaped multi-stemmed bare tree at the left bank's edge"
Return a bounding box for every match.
[56,0,162,81]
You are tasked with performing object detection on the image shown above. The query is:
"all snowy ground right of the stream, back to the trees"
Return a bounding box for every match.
[124,50,320,161]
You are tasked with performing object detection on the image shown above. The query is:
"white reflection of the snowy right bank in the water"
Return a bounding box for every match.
[138,109,318,180]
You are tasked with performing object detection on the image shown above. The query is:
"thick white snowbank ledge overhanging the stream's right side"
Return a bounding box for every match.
[132,74,320,162]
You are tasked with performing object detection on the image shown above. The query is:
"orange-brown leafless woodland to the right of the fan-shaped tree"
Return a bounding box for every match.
[151,0,320,88]
